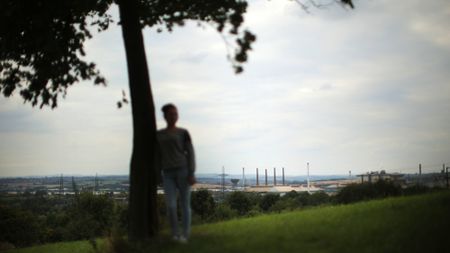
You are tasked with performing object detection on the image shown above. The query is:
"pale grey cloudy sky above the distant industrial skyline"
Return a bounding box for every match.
[0,0,450,177]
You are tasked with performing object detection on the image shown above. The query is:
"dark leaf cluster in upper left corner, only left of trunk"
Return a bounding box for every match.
[0,0,112,108]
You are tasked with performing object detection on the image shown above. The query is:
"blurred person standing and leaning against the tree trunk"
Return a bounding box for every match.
[157,103,195,242]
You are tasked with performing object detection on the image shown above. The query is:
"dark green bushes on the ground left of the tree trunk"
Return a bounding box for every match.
[0,193,118,247]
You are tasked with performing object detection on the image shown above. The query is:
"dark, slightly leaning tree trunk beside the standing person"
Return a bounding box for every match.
[117,0,158,240]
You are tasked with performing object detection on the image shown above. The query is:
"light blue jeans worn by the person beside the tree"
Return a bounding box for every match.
[162,167,191,238]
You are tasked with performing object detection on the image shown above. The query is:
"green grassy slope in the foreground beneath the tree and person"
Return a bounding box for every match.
[4,191,450,253]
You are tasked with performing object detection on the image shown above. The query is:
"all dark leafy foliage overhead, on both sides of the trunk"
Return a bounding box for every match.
[0,0,256,108]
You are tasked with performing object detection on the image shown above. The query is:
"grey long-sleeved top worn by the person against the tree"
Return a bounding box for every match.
[157,128,195,176]
